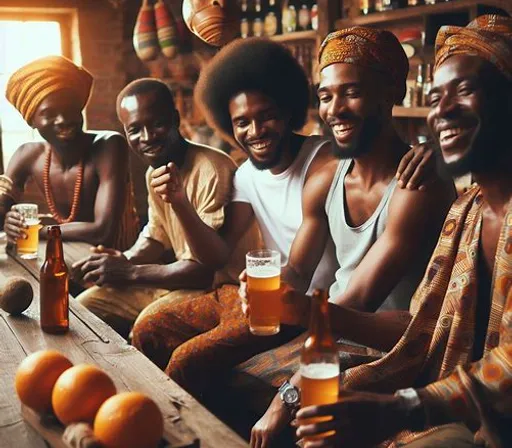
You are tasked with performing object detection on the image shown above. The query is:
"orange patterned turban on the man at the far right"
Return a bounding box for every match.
[434,14,512,80]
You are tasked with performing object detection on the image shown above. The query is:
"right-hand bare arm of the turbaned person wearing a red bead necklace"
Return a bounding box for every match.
[56,134,129,246]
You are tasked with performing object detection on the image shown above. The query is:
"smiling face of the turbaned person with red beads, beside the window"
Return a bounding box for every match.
[30,90,84,149]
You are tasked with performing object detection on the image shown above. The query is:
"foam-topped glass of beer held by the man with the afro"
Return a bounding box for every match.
[245,249,281,336]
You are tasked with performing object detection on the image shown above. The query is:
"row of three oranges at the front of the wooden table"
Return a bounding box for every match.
[15,350,163,448]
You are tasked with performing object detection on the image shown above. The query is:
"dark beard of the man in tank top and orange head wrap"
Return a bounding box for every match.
[330,114,383,159]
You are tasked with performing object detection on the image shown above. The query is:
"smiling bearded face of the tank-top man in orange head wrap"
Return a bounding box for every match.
[318,63,385,158]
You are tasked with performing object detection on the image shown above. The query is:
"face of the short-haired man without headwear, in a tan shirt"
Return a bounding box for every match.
[119,91,183,168]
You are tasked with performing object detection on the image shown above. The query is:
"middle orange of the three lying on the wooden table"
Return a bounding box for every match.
[52,364,116,425]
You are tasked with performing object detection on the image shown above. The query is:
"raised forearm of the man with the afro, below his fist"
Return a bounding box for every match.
[173,200,230,269]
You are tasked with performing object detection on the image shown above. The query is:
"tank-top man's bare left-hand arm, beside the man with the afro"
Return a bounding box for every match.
[282,160,338,292]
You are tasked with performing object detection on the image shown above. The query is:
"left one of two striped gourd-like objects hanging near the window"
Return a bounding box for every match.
[133,0,160,61]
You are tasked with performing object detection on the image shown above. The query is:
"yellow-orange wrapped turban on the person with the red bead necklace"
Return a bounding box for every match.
[5,56,92,123]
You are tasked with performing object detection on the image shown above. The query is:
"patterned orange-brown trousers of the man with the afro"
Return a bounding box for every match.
[132,285,302,394]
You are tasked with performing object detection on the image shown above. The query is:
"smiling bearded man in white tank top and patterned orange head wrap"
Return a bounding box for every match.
[253,28,455,448]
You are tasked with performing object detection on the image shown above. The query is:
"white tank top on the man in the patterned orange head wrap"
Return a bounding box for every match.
[325,159,424,311]
